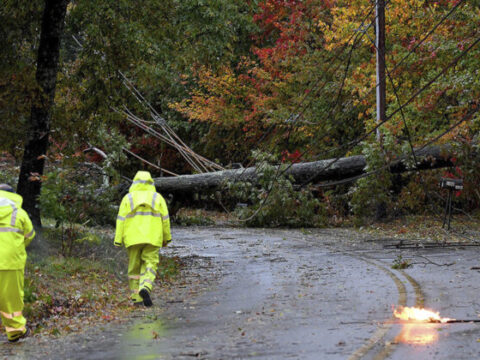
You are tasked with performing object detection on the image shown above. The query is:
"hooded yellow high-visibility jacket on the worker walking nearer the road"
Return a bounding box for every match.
[114,171,172,247]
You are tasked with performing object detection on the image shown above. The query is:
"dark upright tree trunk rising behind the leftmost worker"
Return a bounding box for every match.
[17,0,69,226]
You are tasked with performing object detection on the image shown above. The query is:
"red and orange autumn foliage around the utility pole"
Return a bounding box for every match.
[171,0,479,165]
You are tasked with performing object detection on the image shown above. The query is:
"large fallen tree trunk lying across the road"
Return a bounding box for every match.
[155,146,452,195]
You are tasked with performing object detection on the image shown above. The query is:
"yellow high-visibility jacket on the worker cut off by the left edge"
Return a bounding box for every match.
[0,190,35,270]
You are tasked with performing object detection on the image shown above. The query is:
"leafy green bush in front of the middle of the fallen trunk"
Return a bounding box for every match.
[228,152,325,227]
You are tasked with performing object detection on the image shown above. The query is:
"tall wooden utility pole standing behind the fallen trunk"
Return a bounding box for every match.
[375,0,386,144]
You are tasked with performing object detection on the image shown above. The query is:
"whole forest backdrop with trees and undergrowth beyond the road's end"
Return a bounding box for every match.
[0,0,480,231]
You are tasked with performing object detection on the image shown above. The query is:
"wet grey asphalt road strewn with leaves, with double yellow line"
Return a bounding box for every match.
[0,228,480,359]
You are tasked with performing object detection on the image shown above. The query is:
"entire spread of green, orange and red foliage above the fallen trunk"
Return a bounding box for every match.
[0,0,480,218]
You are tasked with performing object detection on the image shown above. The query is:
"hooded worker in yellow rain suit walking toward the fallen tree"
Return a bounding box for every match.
[114,171,172,306]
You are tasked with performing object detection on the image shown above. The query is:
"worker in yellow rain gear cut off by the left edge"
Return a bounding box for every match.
[0,184,35,342]
